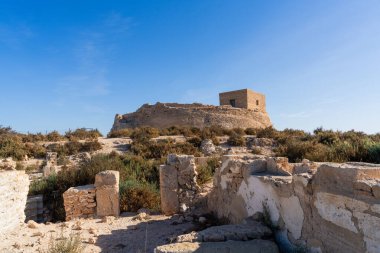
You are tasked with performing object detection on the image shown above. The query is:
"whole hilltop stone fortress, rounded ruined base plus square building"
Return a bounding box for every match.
[112,89,272,130]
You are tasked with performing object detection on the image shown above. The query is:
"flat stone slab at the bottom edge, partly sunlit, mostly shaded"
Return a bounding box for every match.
[154,240,279,253]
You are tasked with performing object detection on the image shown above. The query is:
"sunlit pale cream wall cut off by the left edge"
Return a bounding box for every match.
[0,170,29,234]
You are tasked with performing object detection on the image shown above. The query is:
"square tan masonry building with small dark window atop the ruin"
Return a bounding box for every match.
[219,89,266,112]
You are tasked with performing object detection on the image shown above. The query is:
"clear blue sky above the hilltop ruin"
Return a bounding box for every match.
[0,0,380,133]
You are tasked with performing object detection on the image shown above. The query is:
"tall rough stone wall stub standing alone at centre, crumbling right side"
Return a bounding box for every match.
[160,154,200,215]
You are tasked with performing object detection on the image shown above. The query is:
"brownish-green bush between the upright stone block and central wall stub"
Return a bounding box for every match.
[120,180,160,212]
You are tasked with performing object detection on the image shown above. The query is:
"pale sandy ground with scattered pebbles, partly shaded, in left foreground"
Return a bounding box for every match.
[0,213,194,253]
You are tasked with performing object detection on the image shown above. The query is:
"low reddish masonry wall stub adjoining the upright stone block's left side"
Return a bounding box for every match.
[63,184,96,221]
